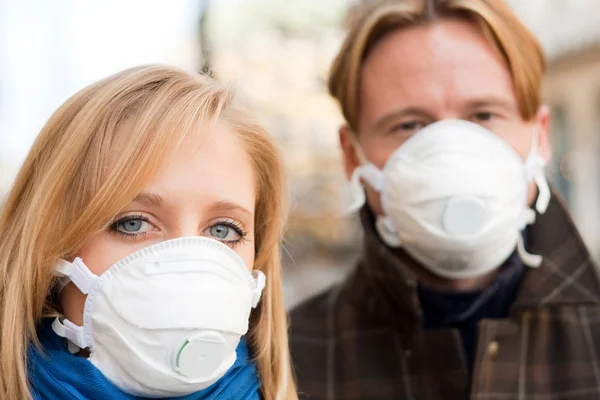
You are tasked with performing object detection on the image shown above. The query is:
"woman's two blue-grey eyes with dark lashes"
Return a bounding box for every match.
[109,214,248,247]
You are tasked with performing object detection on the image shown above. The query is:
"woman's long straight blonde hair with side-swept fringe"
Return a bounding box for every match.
[0,66,297,400]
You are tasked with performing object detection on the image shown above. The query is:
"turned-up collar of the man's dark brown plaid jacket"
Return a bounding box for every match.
[342,194,600,328]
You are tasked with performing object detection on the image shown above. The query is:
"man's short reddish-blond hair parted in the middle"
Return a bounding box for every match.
[329,0,545,131]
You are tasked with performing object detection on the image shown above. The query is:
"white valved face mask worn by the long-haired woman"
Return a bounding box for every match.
[52,237,265,397]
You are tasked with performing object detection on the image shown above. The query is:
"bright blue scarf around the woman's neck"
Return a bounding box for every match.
[28,321,261,400]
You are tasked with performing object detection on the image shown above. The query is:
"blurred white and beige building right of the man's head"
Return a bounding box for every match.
[511,0,600,258]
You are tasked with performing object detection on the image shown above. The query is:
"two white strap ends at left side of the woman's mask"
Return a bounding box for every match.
[52,257,98,349]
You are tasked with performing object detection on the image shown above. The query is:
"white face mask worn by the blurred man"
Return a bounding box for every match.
[352,120,550,279]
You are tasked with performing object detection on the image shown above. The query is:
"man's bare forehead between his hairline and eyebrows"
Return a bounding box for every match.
[360,21,516,117]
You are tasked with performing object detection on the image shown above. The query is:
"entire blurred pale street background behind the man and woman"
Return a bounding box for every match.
[0,0,600,306]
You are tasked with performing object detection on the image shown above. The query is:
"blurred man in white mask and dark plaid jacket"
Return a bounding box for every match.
[291,0,600,400]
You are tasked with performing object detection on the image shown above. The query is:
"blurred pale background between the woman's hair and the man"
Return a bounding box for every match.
[204,0,360,305]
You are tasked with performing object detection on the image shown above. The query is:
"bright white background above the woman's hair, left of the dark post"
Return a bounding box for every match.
[0,0,203,189]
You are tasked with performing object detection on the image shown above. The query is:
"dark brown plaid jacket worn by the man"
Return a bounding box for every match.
[291,192,600,400]
